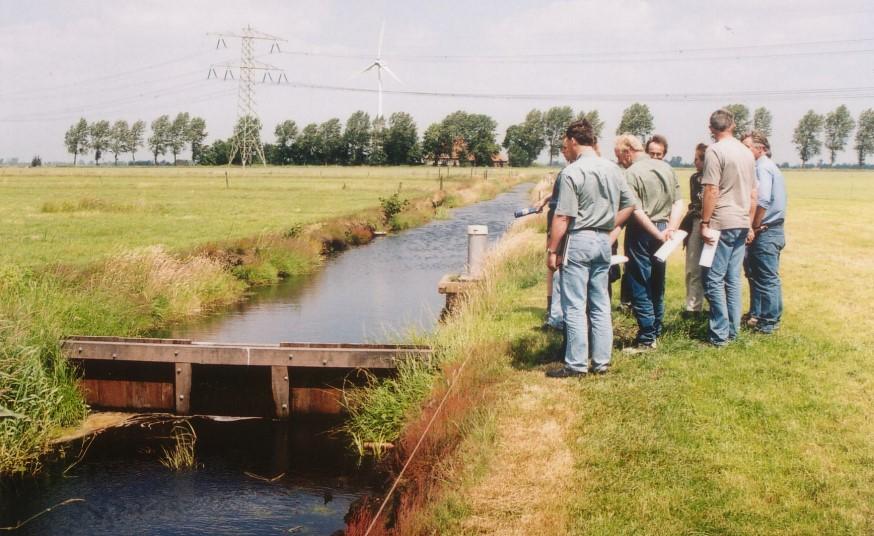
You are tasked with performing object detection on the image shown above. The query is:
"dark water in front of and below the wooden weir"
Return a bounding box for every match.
[0,420,380,535]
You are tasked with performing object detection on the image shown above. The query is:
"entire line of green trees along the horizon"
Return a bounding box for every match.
[65,102,874,167]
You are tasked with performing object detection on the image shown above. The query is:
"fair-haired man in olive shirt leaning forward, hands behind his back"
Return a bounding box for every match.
[614,134,684,352]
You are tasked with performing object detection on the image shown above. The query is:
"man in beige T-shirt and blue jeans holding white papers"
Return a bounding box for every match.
[701,110,756,347]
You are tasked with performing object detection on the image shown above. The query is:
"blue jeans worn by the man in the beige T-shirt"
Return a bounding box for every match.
[704,229,748,346]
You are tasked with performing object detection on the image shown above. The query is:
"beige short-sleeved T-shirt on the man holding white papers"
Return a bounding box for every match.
[701,136,756,230]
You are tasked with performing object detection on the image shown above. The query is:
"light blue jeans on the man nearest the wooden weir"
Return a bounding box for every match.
[561,231,613,372]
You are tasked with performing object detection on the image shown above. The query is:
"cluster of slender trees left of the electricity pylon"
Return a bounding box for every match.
[64,112,207,166]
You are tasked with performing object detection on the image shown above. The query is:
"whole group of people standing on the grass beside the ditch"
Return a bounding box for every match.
[539,109,786,378]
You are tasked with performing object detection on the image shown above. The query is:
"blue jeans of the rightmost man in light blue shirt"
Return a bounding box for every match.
[748,225,786,333]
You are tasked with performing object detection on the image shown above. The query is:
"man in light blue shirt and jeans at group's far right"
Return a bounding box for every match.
[743,131,786,333]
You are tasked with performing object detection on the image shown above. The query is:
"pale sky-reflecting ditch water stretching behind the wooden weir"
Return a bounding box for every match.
[172,185,530,343]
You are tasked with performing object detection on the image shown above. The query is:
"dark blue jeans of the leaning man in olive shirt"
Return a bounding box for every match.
[625,222,668,344]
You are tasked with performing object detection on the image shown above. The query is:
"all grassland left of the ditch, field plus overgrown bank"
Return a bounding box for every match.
[0,168,541,474]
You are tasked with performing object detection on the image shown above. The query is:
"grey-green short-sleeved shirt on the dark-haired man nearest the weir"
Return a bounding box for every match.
[555,147,637,231]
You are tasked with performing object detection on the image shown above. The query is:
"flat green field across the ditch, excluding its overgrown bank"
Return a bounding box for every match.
[0,166,543,266]
